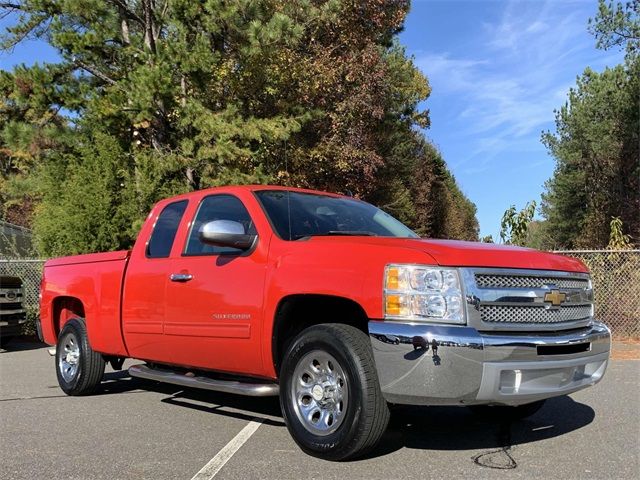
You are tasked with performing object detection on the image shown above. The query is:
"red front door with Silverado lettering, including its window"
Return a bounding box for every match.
[164,194,268,375]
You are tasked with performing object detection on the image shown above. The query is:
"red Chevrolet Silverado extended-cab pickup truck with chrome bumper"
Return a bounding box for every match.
[41,186,610,460]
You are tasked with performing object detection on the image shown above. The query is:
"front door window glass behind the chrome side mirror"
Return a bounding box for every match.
[183,194,257,256]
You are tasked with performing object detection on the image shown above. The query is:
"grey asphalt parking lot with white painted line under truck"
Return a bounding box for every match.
[0,343,640,480]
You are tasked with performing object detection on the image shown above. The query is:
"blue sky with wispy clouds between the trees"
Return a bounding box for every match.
[0,0,623,239]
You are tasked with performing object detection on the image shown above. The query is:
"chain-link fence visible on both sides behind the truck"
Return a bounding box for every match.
[0,250,640,338]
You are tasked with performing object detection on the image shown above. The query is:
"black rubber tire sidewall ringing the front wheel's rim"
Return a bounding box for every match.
[280,327,365,459]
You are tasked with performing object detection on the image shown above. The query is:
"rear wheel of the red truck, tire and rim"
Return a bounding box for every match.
[56,318,105,396]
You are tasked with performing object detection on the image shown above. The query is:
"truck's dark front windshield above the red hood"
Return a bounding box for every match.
[256,190,418,240]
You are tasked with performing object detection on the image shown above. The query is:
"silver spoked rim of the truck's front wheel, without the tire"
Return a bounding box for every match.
[291,350,349,436]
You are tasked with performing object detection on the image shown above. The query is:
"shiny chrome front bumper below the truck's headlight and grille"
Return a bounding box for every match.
[369,321,611,405]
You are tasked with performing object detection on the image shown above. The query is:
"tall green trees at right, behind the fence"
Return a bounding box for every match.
[542,1,640,248]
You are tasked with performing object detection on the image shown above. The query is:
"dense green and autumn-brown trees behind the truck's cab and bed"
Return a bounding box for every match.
[0,0,477,255]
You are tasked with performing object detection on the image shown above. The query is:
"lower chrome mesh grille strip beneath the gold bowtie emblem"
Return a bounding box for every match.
[480,305,591,323]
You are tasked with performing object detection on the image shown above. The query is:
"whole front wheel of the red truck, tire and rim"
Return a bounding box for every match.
[280,324,389,461]
